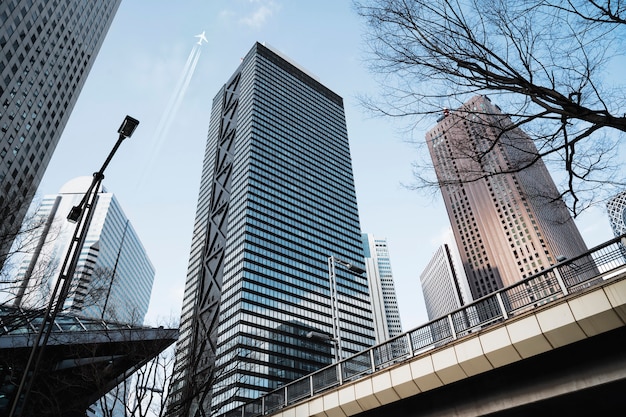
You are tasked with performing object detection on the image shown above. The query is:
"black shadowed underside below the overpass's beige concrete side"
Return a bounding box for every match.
[357,327,626,417]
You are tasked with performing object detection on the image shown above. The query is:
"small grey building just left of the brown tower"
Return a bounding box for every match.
[420,243,471,320]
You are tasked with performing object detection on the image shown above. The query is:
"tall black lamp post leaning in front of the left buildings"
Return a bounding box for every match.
[9,116,139,417]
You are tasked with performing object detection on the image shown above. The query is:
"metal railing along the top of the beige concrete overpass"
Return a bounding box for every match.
[222,235,626,417]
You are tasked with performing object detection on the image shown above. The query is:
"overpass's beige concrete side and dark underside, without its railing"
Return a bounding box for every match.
[272,273,626,417]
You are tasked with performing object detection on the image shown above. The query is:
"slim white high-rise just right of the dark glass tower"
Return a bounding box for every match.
[361,233,402,343]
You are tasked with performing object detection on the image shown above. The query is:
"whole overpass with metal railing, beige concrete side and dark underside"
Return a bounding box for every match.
[224,236,626,417]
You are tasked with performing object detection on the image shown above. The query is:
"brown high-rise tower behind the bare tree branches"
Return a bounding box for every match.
[426,96,587,299]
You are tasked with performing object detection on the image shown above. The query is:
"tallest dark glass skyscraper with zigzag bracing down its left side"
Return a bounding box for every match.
[168,43,375,416]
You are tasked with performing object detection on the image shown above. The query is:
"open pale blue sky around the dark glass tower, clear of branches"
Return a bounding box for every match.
[38,0,612,330]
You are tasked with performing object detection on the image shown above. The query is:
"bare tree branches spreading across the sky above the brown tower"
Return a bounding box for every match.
[355,0,626,215]
